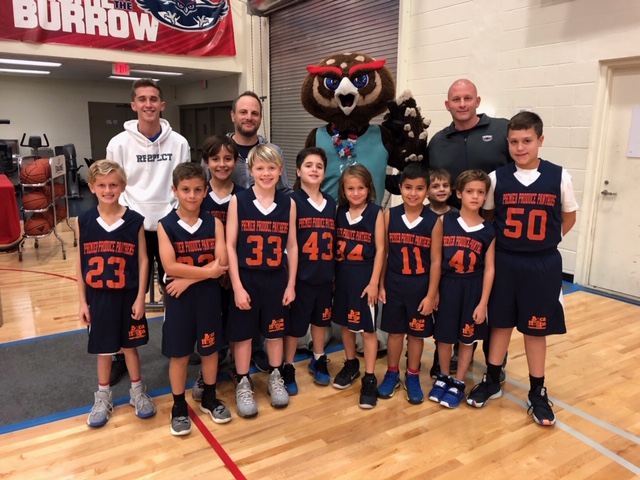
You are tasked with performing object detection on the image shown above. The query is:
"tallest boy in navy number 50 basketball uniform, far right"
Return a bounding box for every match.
[467,112,578,426]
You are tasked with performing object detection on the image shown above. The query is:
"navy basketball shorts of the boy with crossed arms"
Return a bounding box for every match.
[162,280,224,358]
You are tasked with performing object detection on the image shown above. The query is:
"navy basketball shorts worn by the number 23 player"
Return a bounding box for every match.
[86,285,149,355]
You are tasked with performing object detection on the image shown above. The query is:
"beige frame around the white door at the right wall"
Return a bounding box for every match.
[574,57,640,296]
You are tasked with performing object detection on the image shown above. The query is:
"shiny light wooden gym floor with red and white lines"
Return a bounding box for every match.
[0,223,640,480]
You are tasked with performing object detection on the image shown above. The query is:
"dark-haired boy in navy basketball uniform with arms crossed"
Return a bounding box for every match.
[158,163,231,435]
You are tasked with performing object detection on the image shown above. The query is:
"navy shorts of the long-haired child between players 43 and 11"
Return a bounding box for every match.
[332,262,378,333]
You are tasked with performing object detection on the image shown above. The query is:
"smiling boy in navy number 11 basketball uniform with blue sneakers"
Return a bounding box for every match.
[378,163,442,404]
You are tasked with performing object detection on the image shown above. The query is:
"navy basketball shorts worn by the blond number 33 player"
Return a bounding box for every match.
[227,267,289,342]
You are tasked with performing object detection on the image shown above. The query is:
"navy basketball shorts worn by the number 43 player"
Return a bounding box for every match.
[287,280,333,338]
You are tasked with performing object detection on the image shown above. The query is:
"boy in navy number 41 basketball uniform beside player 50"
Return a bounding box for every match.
[429,170,496,408]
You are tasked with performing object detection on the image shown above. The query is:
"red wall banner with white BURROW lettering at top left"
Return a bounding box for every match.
[0,0,236,57]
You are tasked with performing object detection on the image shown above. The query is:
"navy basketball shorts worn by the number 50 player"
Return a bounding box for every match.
[489,250,567,337]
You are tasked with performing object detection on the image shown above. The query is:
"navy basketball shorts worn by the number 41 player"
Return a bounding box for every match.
[433,272,488,345]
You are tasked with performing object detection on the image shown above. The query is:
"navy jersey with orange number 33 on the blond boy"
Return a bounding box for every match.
[236,188,291,270]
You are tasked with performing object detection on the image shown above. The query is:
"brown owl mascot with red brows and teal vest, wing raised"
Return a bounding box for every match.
[301,53,428,203]
